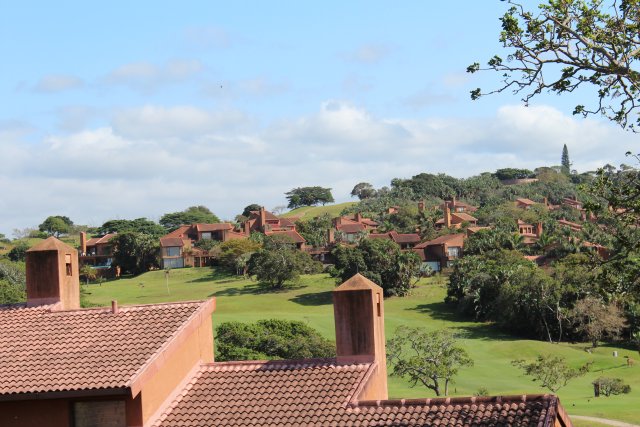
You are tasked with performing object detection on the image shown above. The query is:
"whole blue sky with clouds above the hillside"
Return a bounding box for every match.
[0,0,636,236]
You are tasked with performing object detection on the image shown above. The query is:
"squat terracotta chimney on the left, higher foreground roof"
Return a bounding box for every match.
[27,237,80,310]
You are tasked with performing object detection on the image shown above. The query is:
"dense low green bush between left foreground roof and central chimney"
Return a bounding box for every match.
[216,319,335,362]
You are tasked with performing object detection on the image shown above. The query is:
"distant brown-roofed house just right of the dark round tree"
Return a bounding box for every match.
[160,222,248,268]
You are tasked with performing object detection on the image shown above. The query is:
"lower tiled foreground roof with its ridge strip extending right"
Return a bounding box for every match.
[154,359,558,427]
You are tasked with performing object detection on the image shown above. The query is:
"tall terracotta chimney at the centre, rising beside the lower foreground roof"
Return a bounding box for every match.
[333,274,388,400]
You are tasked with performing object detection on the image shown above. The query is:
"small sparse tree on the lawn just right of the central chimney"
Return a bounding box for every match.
[387,326,473,396]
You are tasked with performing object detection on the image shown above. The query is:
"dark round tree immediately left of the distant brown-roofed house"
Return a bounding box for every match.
[110,231,160,274]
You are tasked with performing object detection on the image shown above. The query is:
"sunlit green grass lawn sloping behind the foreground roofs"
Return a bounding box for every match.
[87,268,640,426]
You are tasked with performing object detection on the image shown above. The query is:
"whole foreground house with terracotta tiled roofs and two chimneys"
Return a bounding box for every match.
[0,238,571,427]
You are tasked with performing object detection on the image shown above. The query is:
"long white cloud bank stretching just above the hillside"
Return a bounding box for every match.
[0,100,636,234]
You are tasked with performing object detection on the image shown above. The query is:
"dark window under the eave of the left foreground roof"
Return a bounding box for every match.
[72,400,127,427]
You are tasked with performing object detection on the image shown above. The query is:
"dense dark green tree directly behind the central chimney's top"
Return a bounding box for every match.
[332,239,422,296]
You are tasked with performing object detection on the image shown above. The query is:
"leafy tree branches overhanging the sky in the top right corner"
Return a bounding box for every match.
[467,0,640,128]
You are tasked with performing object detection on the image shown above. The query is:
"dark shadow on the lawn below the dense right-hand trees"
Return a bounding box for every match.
[407,302,518,341]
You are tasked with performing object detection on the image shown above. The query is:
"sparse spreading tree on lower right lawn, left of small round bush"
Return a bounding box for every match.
[511,355,591,393]
